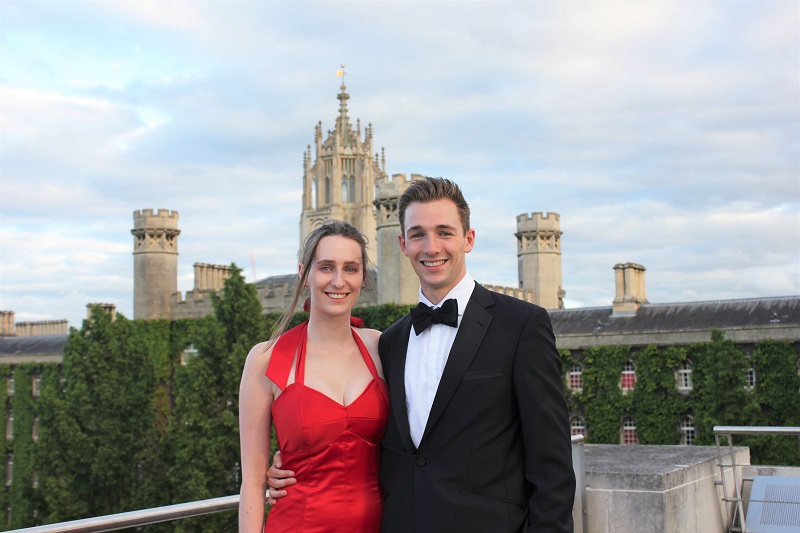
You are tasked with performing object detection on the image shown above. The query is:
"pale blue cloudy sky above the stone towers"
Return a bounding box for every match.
[0,0,800,326]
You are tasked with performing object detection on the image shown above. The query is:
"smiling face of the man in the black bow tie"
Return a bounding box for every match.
[399,199,475,304]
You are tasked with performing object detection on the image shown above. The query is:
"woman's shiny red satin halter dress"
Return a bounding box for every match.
[266,322,389,533]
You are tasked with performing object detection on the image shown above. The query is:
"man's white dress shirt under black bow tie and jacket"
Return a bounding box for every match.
[405,273,475,447]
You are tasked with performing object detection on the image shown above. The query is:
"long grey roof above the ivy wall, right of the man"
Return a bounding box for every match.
[549,296,800,348]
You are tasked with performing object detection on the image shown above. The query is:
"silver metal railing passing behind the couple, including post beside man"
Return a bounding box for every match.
[6,435,587,533]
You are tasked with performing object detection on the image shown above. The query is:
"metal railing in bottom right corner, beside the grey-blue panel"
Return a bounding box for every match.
[714,426,800,533]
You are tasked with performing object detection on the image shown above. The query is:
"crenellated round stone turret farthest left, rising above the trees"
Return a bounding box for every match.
[131,209,181,320]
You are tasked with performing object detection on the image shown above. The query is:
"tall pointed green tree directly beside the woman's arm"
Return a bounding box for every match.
[171,264,264,532]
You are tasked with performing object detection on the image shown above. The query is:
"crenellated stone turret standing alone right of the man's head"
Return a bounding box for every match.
[514,213,566,309]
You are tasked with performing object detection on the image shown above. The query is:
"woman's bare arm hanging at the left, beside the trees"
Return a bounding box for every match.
[239,343,274,533]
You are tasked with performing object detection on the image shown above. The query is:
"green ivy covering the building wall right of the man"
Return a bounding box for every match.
[561,331,800,466]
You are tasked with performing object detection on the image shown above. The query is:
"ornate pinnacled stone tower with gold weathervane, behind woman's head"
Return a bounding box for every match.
[300,80,386,265]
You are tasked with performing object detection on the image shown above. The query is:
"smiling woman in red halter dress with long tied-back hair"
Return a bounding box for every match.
[239,221,389,533]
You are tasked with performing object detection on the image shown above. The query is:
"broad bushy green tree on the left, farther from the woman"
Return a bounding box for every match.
[37,307,169,522]
